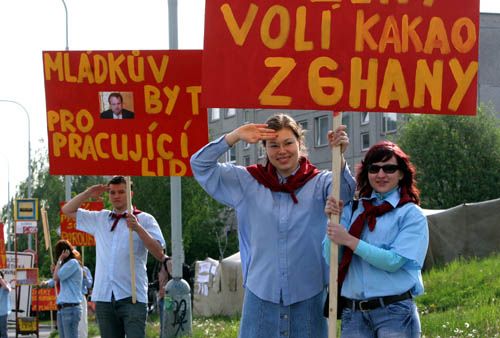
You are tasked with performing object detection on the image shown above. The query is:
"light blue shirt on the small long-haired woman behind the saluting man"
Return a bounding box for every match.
[56,258,83,304]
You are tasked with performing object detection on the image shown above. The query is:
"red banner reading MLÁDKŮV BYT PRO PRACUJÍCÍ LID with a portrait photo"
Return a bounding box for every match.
[43,50,208,176]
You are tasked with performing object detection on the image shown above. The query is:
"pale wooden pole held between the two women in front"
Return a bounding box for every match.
[328,112,342,338]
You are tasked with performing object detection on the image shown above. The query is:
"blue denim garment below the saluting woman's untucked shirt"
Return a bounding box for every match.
[239,289,328,338]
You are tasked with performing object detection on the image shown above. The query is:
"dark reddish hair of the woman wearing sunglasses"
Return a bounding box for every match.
[356,141,420,205]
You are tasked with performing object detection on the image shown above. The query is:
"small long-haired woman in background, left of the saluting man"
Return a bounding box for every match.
[48,239,82,338]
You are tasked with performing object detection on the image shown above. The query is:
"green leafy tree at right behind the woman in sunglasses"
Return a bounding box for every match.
[397,106,500,209]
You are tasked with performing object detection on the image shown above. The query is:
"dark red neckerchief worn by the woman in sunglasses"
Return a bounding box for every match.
[338,187,416,290]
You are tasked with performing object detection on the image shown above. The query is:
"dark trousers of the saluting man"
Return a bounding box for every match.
[95,297,148,338]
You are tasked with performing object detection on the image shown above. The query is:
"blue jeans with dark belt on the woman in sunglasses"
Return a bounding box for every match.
[341,299,421,338]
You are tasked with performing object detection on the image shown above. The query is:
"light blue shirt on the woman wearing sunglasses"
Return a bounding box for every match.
[323,189,429,299]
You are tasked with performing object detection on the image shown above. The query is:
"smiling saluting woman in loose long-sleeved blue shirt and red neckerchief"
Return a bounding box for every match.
[191,114,355,338]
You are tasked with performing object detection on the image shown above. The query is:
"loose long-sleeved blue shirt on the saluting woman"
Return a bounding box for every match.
[191,136,355,305]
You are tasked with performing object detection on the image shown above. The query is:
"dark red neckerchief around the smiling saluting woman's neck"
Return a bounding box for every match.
[247,157,319,203]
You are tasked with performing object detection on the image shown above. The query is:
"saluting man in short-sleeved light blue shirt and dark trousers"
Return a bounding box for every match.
[61,176,168,338]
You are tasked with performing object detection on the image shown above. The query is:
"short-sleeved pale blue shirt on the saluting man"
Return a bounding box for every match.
[76,209,165,303]
